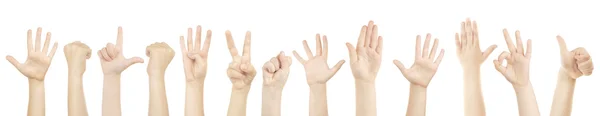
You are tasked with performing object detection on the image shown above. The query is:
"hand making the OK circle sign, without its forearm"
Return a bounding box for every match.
[494,29,531,85]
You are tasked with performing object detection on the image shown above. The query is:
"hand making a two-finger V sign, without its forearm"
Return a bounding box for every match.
[225,30,256,89]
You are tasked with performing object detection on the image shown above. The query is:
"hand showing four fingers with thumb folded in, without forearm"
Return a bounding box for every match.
[179,25,212,82]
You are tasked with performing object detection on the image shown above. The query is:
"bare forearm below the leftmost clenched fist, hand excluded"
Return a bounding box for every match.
[68,71,88,116]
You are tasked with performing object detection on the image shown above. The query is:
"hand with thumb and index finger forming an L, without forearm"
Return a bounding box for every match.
[98,27,144,75]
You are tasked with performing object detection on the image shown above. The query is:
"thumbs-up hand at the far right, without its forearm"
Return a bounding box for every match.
[556,36,594,79]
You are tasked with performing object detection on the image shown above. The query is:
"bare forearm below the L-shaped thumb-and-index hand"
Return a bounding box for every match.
[102,75,121,116]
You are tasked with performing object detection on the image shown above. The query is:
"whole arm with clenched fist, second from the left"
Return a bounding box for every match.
[64,41,92,116]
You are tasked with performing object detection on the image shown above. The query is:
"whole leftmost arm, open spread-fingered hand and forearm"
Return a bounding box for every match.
[6,28,58,116]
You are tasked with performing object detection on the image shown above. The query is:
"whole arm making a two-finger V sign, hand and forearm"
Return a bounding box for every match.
[225,30,256,116]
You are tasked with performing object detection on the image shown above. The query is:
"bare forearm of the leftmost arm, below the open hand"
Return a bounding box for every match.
[27,79,46,116]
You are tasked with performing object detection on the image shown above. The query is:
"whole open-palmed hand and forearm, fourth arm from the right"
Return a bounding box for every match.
[394,34,444,116]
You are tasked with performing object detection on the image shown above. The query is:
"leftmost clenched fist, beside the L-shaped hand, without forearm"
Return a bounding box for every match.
[63,41,92,74]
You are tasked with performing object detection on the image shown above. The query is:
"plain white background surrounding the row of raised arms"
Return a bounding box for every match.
[0,0,600,116]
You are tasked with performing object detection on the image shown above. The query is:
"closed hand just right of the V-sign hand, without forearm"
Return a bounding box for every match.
[263,51,292,89]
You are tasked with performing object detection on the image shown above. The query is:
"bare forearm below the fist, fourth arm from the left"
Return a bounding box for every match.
[148,73,169,116]
